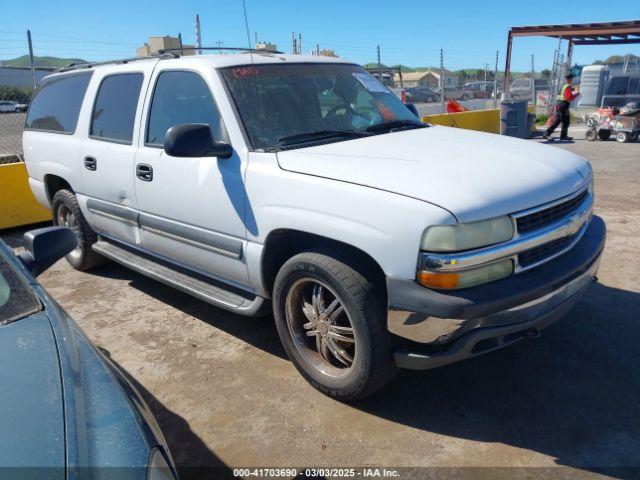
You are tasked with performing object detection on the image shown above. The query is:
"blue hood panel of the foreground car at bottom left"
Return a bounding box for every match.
[0,312,65,472]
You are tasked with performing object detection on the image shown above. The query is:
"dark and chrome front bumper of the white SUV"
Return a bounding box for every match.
[387,216,606,369]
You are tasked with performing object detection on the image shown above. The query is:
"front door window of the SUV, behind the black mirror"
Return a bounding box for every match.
[146,71,228,146]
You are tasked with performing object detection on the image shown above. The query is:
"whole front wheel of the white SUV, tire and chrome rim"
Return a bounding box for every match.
[273,252,398,400]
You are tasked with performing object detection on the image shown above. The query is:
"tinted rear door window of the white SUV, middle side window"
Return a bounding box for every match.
[89,73,143,144]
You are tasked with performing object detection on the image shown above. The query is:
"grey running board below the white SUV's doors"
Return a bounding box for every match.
[92,237,268,316]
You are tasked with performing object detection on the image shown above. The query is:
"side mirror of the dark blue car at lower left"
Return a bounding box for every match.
[19,227,78,276]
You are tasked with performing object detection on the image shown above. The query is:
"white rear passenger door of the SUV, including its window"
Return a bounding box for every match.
[79,64,151,245]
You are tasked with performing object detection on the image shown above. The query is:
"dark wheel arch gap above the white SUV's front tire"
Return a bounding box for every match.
[260,228,386,303]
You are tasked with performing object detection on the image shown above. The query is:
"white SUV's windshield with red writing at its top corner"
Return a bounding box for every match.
[221,63,420,149]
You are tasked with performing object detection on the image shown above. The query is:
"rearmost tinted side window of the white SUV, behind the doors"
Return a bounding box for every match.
[25,72,91,133]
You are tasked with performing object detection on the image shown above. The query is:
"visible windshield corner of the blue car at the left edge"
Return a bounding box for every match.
[0,254,40,325]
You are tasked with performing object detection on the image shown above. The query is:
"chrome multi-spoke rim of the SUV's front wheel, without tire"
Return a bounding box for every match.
[285,278,356,377]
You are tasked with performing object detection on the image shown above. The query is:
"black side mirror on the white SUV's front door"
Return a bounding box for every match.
[164,123,233,158]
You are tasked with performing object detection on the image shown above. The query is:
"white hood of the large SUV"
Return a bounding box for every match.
[278,127,590,222]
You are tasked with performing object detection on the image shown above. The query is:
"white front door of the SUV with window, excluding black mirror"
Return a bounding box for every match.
[135,69,248,285]
